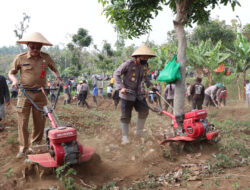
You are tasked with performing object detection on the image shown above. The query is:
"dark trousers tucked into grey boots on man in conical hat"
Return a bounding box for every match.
[121,99,149,123]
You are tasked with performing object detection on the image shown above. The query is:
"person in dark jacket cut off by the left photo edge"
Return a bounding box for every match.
[0,75,10,131]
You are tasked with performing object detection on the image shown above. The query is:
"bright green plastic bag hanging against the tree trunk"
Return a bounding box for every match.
[157,55,181,84]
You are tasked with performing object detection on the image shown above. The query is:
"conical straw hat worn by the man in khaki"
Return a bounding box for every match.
[17,32,53,46]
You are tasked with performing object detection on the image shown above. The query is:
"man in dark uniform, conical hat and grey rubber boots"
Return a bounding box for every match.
[114,45,156,144]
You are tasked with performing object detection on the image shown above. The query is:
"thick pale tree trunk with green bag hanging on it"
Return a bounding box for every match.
[174,0,187,115]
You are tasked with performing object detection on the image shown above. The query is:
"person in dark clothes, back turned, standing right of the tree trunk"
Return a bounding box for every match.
[190,77,205,110]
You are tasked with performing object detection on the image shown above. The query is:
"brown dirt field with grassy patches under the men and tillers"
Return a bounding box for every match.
[0,98,250,190]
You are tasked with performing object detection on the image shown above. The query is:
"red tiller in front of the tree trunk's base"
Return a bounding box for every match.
[160,109,219,144]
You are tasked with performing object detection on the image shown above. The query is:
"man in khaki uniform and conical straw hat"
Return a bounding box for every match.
[9,32,62,158]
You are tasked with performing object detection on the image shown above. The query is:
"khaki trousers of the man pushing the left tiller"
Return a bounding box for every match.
[17,92,47,152]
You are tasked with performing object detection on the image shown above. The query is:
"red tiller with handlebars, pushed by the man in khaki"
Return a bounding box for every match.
[19,87,94,167]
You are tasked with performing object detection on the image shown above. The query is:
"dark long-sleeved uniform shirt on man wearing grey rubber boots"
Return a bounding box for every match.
[114,59,152,101]
